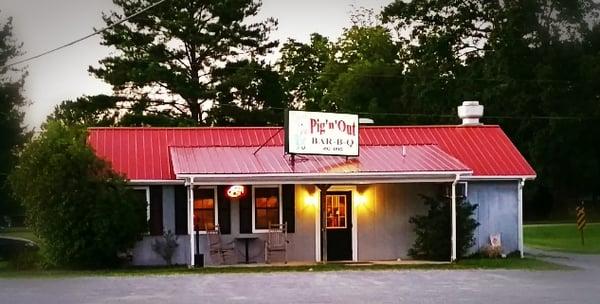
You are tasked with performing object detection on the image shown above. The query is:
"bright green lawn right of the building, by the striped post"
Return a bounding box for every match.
[523,223,600,254]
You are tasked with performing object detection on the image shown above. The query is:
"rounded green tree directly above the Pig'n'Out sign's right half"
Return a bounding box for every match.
[323,24,403,124]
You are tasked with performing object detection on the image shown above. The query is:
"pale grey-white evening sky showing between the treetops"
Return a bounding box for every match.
[0,0,392,127]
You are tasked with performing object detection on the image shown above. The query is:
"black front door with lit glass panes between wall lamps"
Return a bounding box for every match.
[325,191,352,261]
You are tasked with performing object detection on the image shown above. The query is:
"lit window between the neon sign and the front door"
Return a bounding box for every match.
[253,187,281,230]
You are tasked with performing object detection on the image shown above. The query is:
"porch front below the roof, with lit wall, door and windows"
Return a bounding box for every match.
[187,181,460,265]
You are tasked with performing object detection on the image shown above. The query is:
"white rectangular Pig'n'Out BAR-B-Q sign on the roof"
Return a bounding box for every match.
[285,111,359,156]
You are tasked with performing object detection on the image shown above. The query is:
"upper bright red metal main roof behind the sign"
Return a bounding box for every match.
[88,125,535,180]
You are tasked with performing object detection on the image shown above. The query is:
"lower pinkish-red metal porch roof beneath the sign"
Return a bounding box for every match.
[170,145,471,174]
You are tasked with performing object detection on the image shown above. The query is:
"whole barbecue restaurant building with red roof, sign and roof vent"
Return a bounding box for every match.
[88,102,535,265]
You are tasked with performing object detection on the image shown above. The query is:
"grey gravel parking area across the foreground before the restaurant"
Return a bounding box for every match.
[0,251,600,304]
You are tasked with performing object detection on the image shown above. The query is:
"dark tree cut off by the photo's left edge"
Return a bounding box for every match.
[0,14,28,215]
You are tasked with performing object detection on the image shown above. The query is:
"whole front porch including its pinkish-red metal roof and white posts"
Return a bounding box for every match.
[170,145,472,266]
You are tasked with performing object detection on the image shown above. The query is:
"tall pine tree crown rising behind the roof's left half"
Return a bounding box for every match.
[89,0,276,124]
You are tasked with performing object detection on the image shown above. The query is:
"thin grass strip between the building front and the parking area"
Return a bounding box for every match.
[0,258,570,278]
